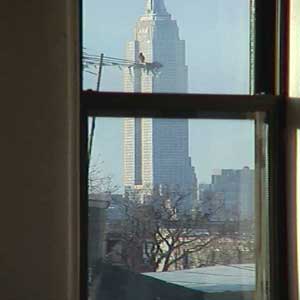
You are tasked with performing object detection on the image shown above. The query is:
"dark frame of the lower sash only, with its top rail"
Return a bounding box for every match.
[81,91,288,299]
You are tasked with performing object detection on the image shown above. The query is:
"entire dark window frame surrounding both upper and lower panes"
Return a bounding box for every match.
[80,0,289,300]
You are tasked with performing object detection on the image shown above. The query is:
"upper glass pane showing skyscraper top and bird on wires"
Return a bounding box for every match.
[83,0,254,94]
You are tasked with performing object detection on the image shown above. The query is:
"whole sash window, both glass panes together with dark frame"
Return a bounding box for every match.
[82,0,286,300]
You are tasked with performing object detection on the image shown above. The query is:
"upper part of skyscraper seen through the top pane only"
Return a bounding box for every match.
[124,0,188,93]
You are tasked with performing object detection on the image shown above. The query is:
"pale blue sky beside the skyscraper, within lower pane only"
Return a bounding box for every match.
[92,117,255,189]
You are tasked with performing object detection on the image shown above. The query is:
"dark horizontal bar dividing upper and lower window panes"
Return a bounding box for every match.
[81,91,283,119]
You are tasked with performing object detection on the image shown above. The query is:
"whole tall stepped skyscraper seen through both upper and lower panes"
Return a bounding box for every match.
[124,0,195,207]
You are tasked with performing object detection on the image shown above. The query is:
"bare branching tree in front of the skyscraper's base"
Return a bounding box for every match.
[106,193,218,272]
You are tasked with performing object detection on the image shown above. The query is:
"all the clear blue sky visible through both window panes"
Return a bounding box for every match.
[83,0,254,188]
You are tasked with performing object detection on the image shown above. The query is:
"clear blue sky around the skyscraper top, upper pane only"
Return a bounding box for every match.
[83,0,250,94]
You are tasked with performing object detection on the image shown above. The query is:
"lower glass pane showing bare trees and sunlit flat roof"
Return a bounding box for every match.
[88,117,268,300]
